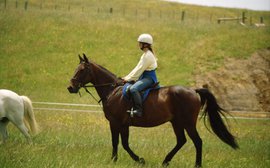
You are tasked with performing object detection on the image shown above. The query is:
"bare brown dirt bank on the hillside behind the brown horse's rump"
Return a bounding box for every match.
[196,48,270,113]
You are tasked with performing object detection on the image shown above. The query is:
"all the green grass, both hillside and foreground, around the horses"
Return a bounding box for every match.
[0,0,270,168]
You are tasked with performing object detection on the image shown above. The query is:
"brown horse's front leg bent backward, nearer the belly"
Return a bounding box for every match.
[121,126,145,164]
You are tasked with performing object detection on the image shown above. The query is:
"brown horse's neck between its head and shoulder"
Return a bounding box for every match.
[93,64,117,99]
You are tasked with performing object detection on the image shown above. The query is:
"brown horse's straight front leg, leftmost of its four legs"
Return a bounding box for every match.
[110,122,120,162]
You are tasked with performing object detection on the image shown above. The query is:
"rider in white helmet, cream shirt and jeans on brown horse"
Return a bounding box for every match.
[123,34,158,117]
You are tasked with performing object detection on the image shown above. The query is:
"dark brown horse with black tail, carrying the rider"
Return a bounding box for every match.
[68,54,238,167]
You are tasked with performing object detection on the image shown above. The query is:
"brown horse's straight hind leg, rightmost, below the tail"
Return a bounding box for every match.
[186,126,202,167]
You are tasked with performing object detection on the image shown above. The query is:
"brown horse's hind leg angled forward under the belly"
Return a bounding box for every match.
[162,121,187,166]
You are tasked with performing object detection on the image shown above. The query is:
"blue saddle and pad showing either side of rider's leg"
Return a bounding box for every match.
[122,82,160,101]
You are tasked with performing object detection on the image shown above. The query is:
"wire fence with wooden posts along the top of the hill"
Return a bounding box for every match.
[0,0,269,25]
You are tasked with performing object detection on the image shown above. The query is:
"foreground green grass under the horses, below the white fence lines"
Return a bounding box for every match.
[0,111,270,168]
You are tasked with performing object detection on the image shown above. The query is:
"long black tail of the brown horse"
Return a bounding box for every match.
[196,88,238,149]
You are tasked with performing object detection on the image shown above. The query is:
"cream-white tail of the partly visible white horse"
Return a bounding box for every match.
[21,96,38,135]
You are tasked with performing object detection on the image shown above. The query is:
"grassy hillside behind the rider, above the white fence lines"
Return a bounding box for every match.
[0,0,270,103]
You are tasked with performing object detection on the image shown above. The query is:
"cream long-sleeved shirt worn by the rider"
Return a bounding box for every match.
[124,50,157,81]
